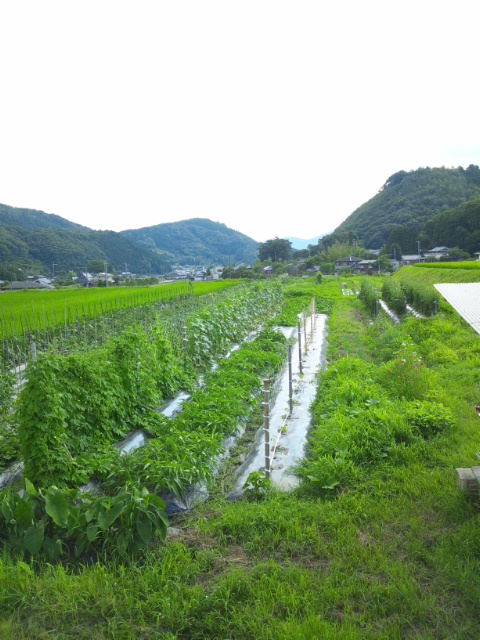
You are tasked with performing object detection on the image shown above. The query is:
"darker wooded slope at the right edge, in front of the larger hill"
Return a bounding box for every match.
[423,199,480,255]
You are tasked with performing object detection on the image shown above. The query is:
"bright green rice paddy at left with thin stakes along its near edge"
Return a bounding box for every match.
[0,281,240,369]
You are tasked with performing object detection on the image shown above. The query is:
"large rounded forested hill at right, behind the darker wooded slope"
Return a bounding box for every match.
[335,165,480,253]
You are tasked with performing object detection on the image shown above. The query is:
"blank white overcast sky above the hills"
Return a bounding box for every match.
[0,0,480,241]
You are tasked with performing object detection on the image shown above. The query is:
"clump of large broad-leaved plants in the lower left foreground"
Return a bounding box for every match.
[0,478,168,560]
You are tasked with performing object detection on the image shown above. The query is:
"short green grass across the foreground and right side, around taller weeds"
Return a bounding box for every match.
[0,270,480,640]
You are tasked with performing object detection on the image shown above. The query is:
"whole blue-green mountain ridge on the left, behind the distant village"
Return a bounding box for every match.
[0,204,258,274]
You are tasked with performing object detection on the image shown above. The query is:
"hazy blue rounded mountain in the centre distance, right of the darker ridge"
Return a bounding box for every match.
[120,218,258,265]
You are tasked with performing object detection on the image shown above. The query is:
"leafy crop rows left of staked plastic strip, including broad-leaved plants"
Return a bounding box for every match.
[0,282,308,559]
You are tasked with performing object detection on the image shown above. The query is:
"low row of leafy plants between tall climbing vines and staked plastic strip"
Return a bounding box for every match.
[101,329,286,496]
